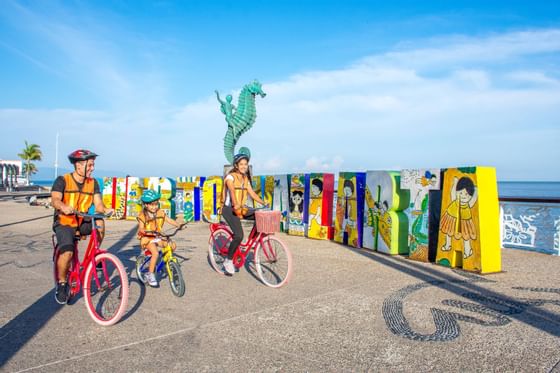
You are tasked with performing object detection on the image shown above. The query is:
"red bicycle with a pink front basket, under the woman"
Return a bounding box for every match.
[208,211,292,288]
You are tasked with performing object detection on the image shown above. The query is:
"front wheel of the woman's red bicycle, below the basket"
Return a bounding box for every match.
[254,236,292,288]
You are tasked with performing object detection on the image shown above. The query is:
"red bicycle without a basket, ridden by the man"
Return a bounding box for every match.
[52,213,128,326]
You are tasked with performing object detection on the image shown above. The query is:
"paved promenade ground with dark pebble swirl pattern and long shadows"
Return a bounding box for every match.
[0,201,560,372]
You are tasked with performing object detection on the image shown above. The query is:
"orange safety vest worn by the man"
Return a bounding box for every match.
[58,174,95,227]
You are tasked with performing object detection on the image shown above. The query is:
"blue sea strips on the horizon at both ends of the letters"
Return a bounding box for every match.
[33,180,560,198]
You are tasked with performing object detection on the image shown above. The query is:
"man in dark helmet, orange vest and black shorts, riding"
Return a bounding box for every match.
[51,149,112,304]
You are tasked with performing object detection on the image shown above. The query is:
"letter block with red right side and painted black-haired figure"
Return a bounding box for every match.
[305,174,334,240]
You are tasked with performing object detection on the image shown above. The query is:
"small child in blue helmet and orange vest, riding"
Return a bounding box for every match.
[136,189,181,286]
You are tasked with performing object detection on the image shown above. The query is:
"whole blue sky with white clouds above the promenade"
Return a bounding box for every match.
[0,0,560,180]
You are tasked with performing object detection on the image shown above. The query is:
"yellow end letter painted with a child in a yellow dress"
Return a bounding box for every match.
[436,167,501,273]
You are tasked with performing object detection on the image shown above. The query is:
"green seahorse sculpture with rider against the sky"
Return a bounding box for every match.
[215,80,266,164]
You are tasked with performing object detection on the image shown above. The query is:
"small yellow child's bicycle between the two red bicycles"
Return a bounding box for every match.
[136,224,185,297]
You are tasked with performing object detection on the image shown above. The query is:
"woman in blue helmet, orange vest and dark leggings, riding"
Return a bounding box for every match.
[222,154,266,275]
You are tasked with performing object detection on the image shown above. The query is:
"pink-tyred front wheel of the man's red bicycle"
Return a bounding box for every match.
[84,253,128,326]
